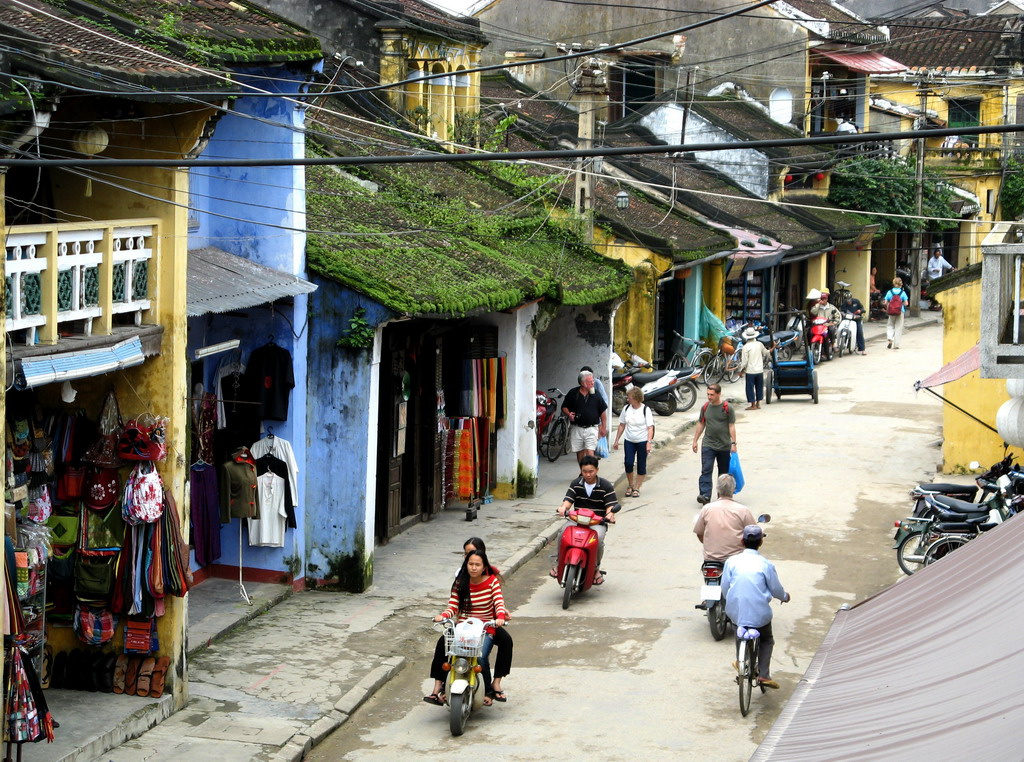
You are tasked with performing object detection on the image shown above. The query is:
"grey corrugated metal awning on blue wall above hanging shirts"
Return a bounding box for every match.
[187,246,316,318]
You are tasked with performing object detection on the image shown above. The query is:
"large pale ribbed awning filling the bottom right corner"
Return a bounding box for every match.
[751,505,1024,762]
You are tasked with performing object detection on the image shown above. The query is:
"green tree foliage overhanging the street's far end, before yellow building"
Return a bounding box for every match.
[828,159,956,232]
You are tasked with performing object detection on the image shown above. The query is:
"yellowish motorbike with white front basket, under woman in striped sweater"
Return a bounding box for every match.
[433,618,498,735]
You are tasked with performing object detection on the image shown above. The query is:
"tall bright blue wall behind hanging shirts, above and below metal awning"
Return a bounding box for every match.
[188,67,310,578]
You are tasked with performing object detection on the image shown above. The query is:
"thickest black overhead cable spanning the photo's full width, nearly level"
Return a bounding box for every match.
[0,124,1024,169]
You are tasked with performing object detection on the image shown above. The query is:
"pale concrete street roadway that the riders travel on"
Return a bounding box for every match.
[310,325,941,760]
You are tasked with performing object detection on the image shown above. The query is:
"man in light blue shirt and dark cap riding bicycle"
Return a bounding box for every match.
[722,523,790,688]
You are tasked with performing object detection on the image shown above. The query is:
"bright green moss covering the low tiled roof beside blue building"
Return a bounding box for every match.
[306,143,633,318]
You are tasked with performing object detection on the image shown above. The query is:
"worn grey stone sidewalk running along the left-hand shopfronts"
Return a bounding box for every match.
[88,312,939,762]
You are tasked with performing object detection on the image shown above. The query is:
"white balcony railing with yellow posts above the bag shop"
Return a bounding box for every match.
[4,219,159,344]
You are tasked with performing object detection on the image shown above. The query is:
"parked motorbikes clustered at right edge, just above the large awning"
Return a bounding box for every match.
[893,455,1024,575]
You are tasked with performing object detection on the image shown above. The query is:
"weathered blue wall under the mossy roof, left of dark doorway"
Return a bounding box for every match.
[305,276,394,592]
